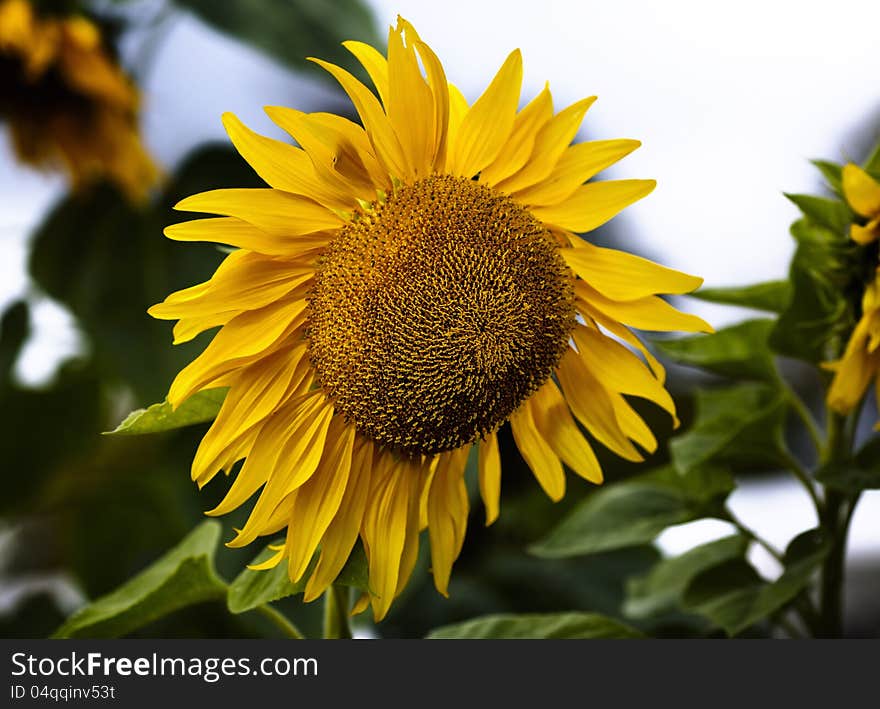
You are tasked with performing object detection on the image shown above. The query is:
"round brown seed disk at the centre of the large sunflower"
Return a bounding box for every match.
[309,176,574,455]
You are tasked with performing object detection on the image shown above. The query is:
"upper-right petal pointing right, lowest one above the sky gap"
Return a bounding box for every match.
[531,180,657,233]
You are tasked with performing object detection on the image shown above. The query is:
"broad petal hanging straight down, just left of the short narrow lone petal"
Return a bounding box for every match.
[428,446,469,596]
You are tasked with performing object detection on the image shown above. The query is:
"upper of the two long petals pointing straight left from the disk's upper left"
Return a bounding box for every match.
[174,189,343,237]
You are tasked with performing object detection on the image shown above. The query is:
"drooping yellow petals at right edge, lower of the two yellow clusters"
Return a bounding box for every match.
[825,271,880,414]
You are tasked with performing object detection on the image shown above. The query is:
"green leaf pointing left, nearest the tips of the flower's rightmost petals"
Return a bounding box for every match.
[653,319,778,382]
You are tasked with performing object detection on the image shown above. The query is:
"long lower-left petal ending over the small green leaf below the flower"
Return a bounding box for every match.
[287,416,354,583]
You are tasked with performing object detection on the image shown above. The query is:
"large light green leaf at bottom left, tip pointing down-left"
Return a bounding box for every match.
[53,520,226,638]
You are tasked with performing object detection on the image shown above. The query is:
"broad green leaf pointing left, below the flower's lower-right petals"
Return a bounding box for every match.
[529,466,733,558]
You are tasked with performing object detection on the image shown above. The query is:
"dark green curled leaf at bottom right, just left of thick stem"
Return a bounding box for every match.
[683,530,830,636]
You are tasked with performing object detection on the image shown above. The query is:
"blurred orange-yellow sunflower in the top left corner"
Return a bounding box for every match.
[0,0,158,198]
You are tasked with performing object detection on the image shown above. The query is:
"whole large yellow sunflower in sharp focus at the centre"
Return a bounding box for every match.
[150,13,711,620]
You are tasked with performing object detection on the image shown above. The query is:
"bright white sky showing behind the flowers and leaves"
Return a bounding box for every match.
[0,0,880,580]
